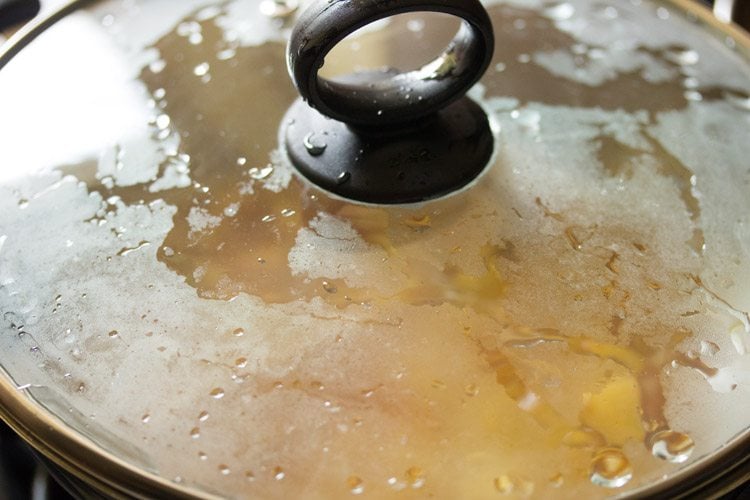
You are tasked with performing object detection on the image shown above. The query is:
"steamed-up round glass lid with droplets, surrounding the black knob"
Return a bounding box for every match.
[0,0,750,498]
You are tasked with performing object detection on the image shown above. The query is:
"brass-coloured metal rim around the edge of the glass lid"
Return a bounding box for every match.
[0,0,750,499]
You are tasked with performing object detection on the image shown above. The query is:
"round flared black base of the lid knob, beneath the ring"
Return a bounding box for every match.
[281,97,494,204]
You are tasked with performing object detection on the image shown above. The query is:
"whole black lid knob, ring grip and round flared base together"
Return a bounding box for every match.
[282,0,494,203]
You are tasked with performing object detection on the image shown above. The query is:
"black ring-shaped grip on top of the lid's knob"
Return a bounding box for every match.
[287,0,495,127]
